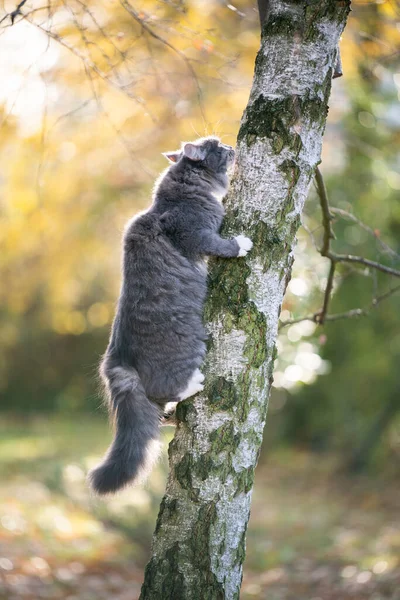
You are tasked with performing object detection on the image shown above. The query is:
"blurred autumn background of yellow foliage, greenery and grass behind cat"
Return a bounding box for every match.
[0,0,400,600]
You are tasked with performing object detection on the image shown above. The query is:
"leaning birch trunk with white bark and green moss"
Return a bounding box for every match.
[140,0,350,600]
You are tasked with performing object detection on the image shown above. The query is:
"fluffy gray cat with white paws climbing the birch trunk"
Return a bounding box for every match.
[89,137,252,494]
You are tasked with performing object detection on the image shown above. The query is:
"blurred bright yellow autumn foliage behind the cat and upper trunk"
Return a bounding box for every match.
[0,0,399,343]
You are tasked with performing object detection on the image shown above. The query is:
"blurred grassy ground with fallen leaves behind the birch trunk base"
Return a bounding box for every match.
[0,416,400,600]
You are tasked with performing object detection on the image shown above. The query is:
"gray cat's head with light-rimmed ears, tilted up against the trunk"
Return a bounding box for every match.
[164,136,235,175]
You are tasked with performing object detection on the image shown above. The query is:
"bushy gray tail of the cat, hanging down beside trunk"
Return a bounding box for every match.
[89,359,160,494]
